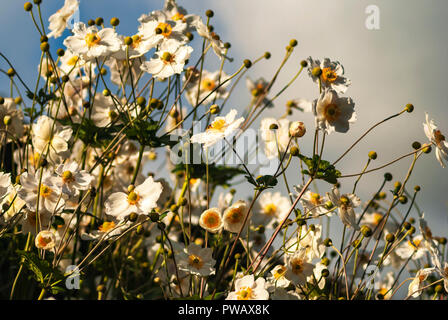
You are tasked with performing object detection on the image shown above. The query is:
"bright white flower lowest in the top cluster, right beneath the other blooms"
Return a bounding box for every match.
[140,39,193,79]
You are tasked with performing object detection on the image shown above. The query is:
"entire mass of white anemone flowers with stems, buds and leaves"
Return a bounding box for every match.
[0,0,448,300]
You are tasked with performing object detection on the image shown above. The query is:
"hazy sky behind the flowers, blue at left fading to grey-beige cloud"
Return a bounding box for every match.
[0,0,448,250]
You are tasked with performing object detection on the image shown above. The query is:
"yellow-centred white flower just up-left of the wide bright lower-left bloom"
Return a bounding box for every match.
[55,161,93,197]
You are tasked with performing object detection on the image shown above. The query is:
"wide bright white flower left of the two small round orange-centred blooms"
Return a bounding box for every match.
[105,177,162,220]
